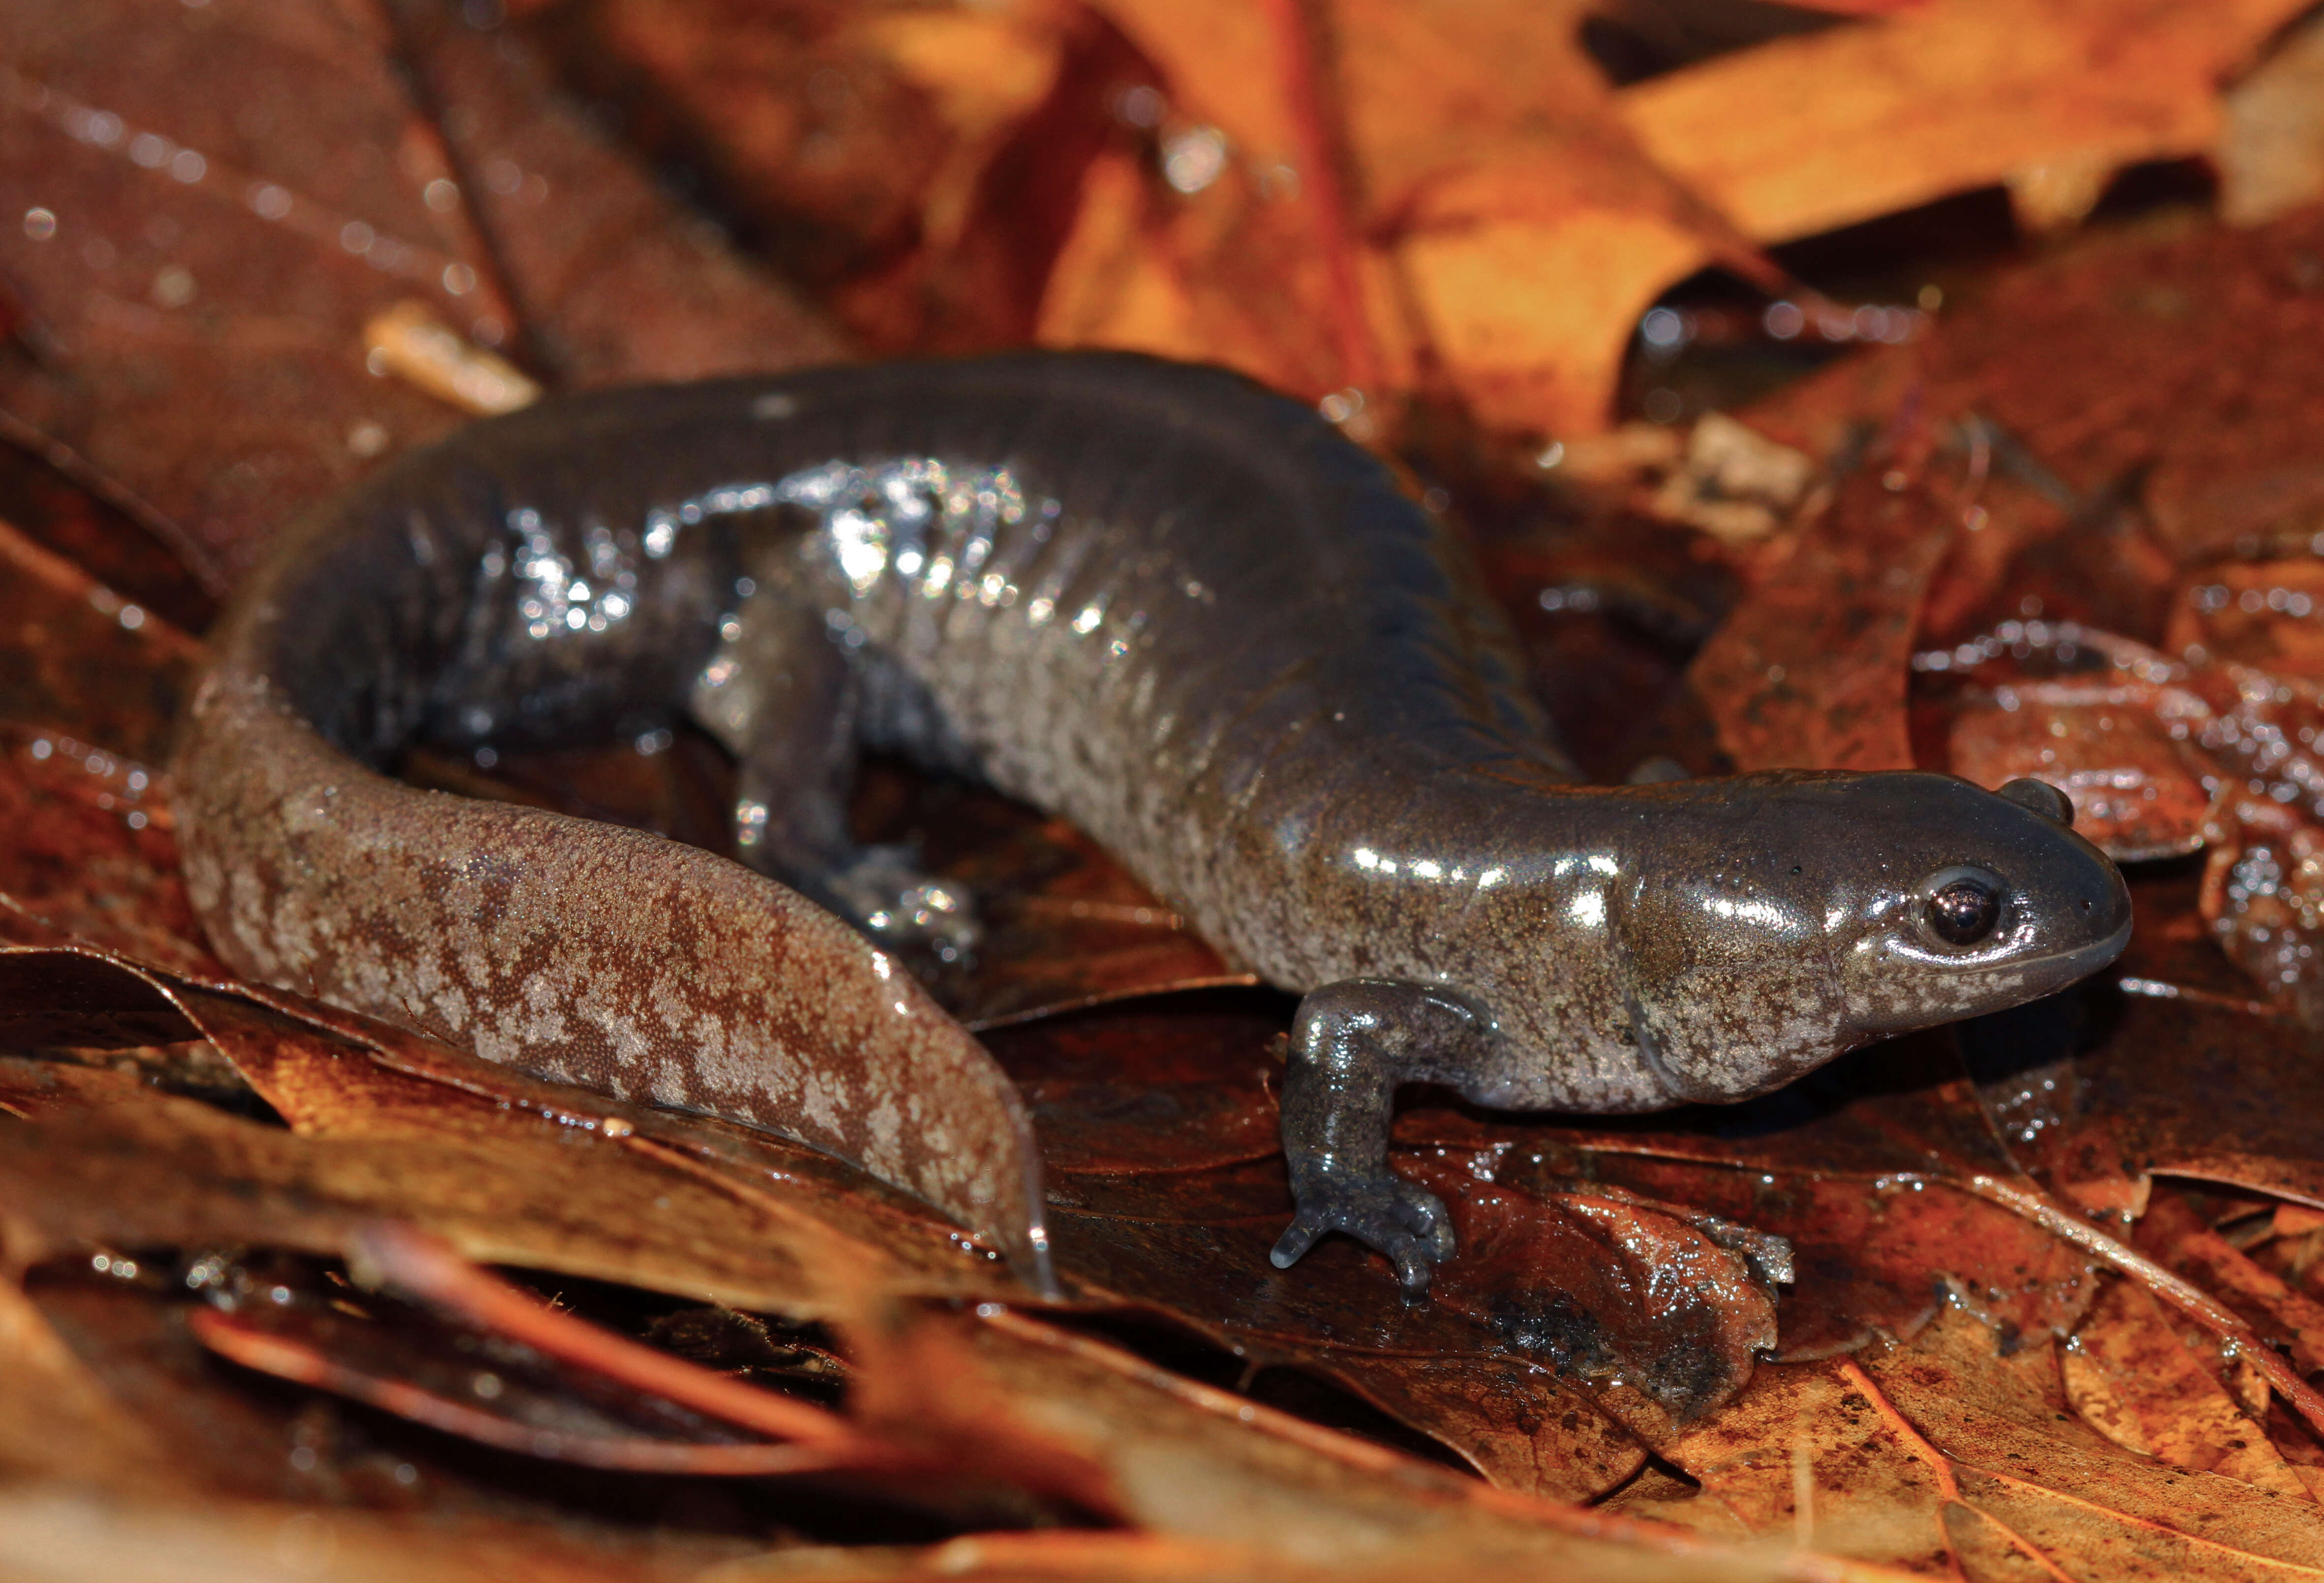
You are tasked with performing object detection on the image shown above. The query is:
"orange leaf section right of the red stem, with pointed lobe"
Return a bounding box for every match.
[1332,2,1778,435]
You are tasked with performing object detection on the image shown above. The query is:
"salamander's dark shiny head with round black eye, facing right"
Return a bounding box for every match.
[1622,772,2131,1100]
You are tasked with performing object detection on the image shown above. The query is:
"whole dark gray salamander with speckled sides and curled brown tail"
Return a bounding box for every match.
[177,353,2129,1290]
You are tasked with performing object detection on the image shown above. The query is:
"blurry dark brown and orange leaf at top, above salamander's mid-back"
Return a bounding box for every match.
[525,0,1097,351]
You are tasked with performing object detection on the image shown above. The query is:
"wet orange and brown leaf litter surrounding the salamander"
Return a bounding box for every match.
[0,0,2324,1579]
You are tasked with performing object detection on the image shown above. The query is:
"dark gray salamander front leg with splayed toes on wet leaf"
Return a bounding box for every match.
[1271,979,1499,1297]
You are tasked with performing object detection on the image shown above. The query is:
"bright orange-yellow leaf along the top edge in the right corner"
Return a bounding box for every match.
[1618,0,2301,242]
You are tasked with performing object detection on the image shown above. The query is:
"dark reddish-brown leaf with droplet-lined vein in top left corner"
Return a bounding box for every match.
[0,4,481,583]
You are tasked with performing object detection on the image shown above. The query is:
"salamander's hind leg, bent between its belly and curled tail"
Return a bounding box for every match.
[690,581,981,972]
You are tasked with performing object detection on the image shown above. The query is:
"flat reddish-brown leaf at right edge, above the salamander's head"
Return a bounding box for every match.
[1745,209,2324,600]
